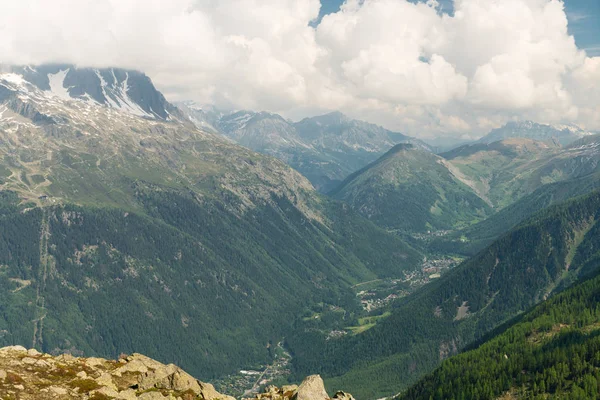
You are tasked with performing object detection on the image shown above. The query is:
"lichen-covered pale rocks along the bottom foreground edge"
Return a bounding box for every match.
[0,346,354,400]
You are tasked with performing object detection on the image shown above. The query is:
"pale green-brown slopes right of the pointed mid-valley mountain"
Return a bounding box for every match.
[442,136,600,208]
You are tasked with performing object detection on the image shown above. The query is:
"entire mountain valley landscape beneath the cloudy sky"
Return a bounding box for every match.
[0,64,600,400]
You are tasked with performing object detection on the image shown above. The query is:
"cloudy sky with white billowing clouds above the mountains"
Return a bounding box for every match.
[0,0,600,138]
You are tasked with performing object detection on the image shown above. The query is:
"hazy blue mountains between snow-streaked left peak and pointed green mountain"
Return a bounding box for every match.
[178,108,432,193]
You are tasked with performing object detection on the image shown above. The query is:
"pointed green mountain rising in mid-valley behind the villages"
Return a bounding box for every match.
[330,144,490,232]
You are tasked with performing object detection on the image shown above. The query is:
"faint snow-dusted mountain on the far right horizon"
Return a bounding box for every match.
[479,121,592,145]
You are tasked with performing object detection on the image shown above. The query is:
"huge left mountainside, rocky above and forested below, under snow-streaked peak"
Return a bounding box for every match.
[0,67,421,377]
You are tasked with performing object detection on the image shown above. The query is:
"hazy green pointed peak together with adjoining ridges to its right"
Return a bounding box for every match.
[329,135,600,234]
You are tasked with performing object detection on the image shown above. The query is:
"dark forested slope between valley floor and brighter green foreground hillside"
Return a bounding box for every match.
[292,191,600,398]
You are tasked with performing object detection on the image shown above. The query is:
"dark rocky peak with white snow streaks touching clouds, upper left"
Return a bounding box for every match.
[10,64,177,120]
